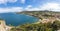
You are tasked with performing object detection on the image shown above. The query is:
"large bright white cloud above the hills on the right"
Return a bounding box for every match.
[40,3,60,10]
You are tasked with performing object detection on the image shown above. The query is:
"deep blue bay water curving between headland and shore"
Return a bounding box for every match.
[0,13,38,26]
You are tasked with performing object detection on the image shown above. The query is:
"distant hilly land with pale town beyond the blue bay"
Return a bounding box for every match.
[17,10,60,23]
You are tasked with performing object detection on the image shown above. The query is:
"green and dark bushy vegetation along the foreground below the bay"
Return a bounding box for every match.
[11,20,60,31]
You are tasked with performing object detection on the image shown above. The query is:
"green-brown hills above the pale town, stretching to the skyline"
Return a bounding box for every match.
[17,10,60,19]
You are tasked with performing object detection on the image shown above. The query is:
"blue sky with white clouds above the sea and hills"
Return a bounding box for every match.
[0,0,60,13]
